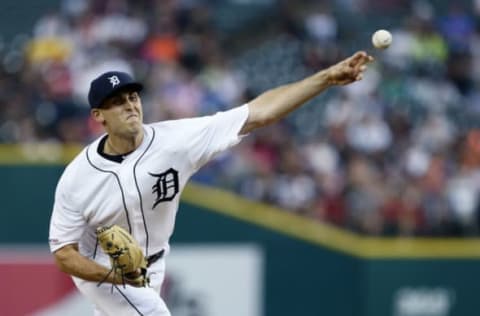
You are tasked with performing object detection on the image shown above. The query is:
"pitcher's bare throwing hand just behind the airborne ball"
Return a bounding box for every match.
[326,51,374,85]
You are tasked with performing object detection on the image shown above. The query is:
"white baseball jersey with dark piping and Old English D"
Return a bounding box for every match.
[49,105,248,265]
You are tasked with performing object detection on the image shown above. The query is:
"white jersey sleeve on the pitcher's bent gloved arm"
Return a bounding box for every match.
[48,172,86,253]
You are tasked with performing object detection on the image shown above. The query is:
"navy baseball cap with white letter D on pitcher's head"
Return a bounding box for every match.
[88,71,143,109]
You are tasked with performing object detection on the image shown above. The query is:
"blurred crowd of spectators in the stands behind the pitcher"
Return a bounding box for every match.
[0,0,480,236]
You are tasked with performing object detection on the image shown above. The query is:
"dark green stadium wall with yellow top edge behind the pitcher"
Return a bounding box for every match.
[0,161,480,316]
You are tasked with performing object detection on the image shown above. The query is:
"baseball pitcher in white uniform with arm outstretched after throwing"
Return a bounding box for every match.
[49,52,373,316]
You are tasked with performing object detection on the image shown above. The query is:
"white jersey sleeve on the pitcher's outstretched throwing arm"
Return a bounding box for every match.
[186,104,249,170]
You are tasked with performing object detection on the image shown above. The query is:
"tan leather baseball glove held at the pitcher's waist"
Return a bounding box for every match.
[97,225,149,287]
